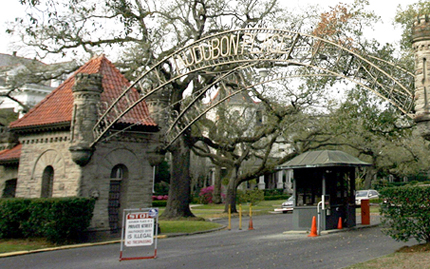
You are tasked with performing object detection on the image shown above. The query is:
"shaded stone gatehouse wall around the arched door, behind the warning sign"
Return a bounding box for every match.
[81,136,153,230]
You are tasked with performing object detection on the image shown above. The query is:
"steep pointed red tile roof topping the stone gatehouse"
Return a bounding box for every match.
[10,55,156,129]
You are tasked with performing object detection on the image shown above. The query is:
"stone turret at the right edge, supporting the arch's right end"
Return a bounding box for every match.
[412,15,430,140]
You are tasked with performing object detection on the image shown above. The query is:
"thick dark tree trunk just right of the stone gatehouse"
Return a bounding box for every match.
[160,137,195,219]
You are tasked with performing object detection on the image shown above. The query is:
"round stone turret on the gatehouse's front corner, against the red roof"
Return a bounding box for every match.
[69,73,103,166]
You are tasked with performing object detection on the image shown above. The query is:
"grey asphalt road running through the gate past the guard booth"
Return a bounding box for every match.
[0,214,416,269]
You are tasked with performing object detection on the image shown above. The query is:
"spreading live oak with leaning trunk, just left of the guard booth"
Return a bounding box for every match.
[193,80,352,212]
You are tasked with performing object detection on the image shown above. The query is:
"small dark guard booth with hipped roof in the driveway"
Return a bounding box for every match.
[277,150,370,231]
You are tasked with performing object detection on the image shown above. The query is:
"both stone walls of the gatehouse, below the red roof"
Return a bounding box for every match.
[16,127,156,230]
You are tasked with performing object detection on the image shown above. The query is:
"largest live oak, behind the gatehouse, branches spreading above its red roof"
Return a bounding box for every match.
[8,0,284,218]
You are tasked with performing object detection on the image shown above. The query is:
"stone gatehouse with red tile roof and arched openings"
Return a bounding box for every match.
[0,56,158,232]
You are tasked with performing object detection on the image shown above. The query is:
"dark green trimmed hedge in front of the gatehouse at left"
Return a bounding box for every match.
[0,198,95,244]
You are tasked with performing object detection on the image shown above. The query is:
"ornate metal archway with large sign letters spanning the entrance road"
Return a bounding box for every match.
[92,28,415,147]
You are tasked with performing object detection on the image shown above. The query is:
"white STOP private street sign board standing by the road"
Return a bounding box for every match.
[124,213,154,247]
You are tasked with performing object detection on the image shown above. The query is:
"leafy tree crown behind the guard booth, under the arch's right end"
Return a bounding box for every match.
[330,89,430,189]
